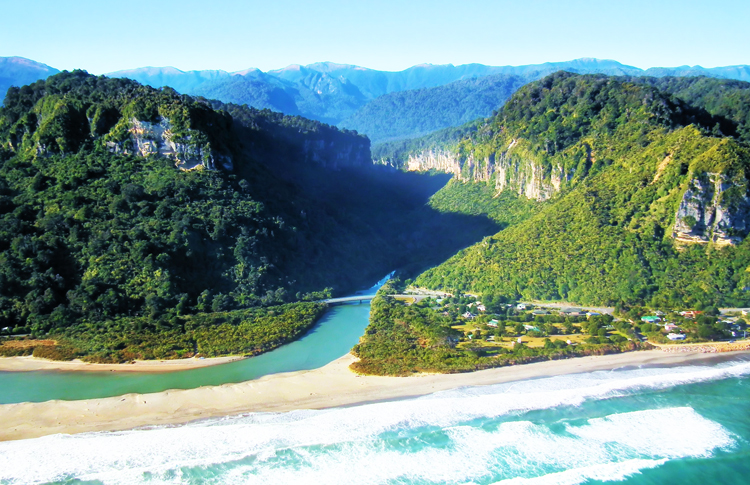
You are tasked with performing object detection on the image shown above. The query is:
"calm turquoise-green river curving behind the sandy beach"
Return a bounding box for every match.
[0,275,390,404]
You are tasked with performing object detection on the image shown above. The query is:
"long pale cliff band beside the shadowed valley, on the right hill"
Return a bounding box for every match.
[406,140,572,201]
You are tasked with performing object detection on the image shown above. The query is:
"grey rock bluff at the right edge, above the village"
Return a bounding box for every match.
[672,173,750,246]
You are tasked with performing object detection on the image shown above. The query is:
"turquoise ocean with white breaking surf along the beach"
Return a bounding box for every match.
[0,359,750,485]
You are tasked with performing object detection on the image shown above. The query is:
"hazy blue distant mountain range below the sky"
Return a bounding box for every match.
[0,57,750,142]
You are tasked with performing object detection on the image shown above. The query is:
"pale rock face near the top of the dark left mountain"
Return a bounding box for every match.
[105,118,233,170]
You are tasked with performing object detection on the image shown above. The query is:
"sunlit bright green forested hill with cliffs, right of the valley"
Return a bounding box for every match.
[407,73,750,306]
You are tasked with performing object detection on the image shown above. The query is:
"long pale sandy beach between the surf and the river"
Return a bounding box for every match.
[0,350,750,441]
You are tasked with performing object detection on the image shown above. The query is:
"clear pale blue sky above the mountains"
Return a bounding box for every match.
[0,0,750,74]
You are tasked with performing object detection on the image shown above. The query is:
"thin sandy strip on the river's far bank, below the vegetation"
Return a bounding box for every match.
[0,355,246,373]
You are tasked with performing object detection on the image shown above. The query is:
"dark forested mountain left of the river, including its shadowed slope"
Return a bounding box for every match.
[0,71,497,360]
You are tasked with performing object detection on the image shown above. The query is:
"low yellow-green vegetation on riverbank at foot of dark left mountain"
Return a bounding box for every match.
[0,303,326,363]
